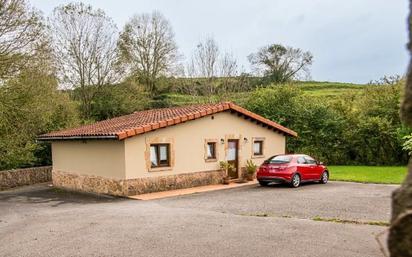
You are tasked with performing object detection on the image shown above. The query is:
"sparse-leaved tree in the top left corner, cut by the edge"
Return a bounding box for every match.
[0,0,44,79]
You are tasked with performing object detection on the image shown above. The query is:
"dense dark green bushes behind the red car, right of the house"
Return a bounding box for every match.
[246,85,409,165]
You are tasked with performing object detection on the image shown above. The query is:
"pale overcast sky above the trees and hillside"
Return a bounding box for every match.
[30,0,408,83]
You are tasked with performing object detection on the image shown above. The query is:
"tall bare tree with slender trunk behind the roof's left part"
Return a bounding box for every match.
[50,3,119,117]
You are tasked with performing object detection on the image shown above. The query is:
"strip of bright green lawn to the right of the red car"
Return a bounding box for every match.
[328,166,407,184]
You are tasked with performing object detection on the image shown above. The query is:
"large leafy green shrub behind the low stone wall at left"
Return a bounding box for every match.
[0,69,79,170]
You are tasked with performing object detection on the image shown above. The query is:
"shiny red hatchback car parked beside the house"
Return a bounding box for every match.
[256,154,329,187]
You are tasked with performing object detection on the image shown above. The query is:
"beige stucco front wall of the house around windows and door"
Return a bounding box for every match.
[125,112,285,179]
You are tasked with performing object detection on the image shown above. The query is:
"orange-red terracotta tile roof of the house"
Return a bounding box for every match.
[38,102,297,140]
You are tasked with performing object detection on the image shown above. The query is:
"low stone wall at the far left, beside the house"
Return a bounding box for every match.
[0,166,52,191]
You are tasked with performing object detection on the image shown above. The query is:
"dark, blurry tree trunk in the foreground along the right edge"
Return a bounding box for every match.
[388,0,412,257]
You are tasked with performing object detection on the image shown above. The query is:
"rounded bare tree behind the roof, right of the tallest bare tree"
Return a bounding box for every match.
[119,11,178,94]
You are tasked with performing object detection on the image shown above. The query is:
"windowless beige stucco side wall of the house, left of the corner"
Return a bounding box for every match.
[52,140,125,179]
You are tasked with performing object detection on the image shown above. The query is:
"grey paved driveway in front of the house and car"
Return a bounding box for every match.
[0,182,396,257]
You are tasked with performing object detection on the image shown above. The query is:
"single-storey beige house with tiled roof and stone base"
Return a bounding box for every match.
[38,102,297,196]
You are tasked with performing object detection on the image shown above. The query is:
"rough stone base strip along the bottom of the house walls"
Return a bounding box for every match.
[52,171,223,196]
